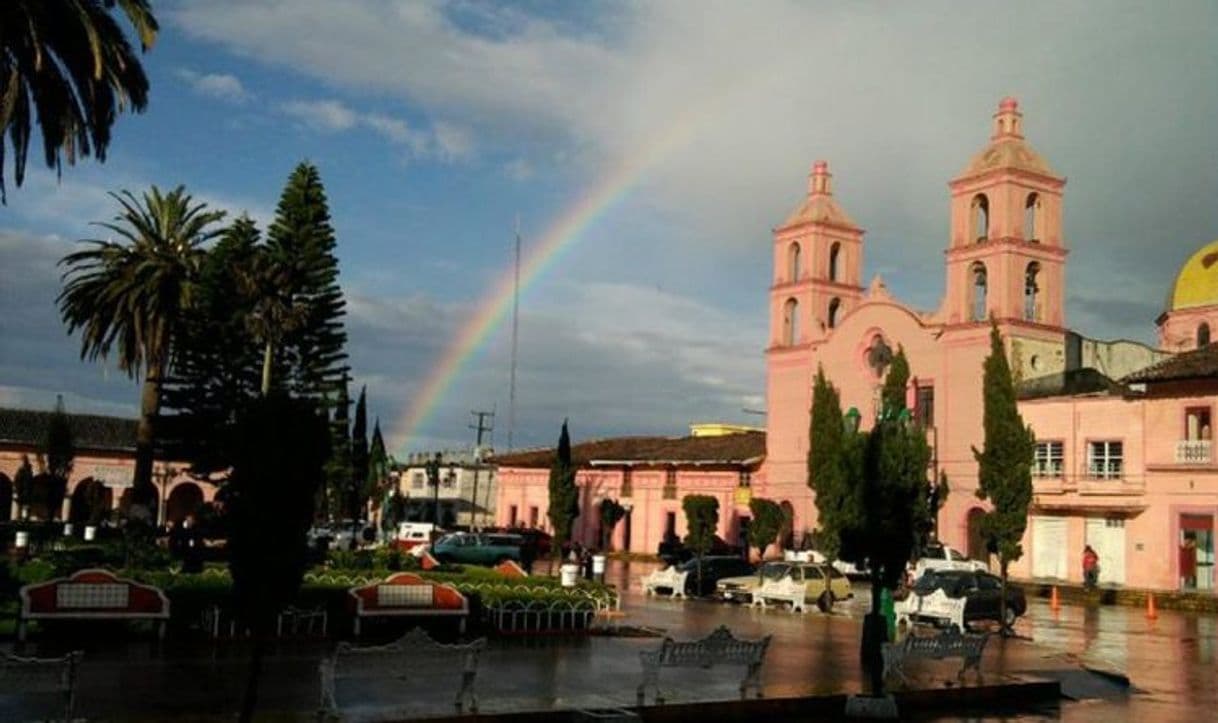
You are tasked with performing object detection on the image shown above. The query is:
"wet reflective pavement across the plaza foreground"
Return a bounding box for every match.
[0,562,1218,723]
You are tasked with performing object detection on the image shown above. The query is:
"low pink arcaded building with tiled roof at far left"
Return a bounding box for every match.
[0,408,216,523]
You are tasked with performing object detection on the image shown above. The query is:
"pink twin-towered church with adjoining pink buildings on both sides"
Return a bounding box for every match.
[498,97,1218,589]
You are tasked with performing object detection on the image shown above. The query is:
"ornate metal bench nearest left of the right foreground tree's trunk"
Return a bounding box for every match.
[637,626,772,705]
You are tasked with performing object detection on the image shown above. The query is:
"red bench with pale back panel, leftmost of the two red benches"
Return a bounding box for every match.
[17,570,169,641]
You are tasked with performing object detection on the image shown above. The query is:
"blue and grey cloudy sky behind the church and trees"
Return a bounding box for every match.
[0,0,1218,454]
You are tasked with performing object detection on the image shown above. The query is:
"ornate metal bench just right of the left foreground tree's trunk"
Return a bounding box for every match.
[319,628,486,714]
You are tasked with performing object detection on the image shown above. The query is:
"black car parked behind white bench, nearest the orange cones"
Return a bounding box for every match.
[901,570,1028,627]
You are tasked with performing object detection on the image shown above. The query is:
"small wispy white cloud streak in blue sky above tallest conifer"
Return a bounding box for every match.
[280,99,474,162]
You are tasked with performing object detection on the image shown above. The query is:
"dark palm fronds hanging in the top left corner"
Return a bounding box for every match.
[0,0,160,202]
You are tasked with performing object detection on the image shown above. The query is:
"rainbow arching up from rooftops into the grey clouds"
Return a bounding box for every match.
[391,82,739,452]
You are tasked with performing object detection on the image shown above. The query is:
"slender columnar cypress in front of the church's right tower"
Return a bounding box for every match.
[973,321,1037,634]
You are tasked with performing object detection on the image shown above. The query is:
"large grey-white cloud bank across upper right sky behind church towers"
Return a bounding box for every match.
[171,0,1218,348]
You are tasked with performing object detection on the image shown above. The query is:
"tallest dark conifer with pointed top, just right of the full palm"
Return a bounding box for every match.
[267,163,348,403]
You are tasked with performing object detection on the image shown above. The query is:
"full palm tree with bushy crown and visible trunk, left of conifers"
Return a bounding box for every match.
[56,186,224,499]
